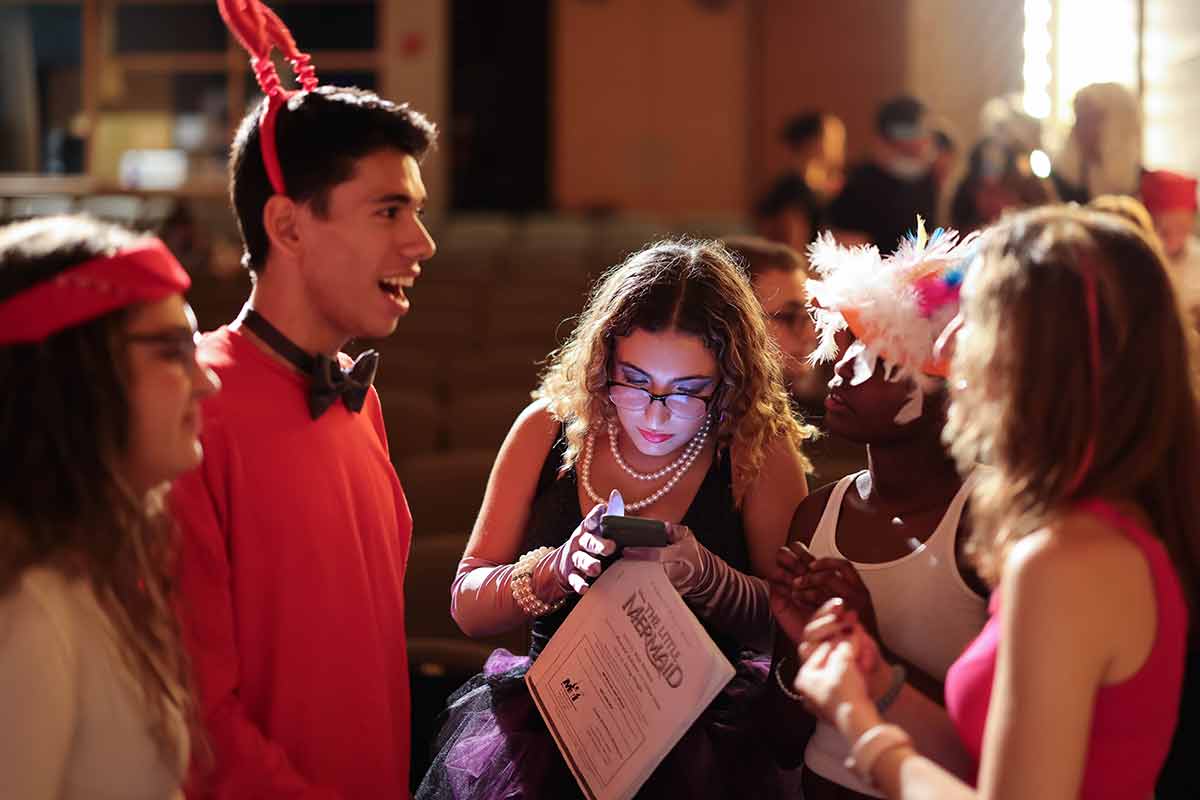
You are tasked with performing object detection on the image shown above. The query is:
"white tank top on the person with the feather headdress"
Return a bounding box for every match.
[804,473,988,798]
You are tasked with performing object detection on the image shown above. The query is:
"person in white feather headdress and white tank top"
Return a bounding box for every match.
[772,218,986,800]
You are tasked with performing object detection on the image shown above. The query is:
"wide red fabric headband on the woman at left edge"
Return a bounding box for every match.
[0,239,192,345]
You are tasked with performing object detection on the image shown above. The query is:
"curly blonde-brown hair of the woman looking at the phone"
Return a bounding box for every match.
[534,240,816,504]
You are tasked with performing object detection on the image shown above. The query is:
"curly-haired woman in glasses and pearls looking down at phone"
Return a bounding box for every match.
[418,240,812,800]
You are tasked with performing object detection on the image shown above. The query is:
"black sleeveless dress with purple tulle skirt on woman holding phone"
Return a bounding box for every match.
[416,435,799,800]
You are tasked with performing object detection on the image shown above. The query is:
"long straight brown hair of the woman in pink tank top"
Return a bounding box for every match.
[946,206,1200,618]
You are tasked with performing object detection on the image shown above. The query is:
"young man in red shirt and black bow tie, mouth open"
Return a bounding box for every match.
[172,86,436,800]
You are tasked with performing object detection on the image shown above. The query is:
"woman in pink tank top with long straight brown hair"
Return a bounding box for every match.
[796,206,1200,800]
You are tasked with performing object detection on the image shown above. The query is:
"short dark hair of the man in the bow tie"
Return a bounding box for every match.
[229,86,437,272]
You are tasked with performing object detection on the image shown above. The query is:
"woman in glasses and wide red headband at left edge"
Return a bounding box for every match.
[0,217,218,800]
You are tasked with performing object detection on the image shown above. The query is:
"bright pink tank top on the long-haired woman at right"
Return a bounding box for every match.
[946,501,1188,800]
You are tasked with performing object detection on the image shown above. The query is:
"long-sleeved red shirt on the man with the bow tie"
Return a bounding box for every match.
[172,329,413,800]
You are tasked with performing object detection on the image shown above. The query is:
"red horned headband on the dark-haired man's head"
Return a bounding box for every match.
[217,0,317,196]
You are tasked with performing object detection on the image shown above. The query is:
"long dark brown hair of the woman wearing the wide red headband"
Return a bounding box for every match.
[0,217,193,764]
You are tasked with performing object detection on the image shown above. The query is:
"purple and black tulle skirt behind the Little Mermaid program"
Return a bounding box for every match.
[416,650,800,800]
